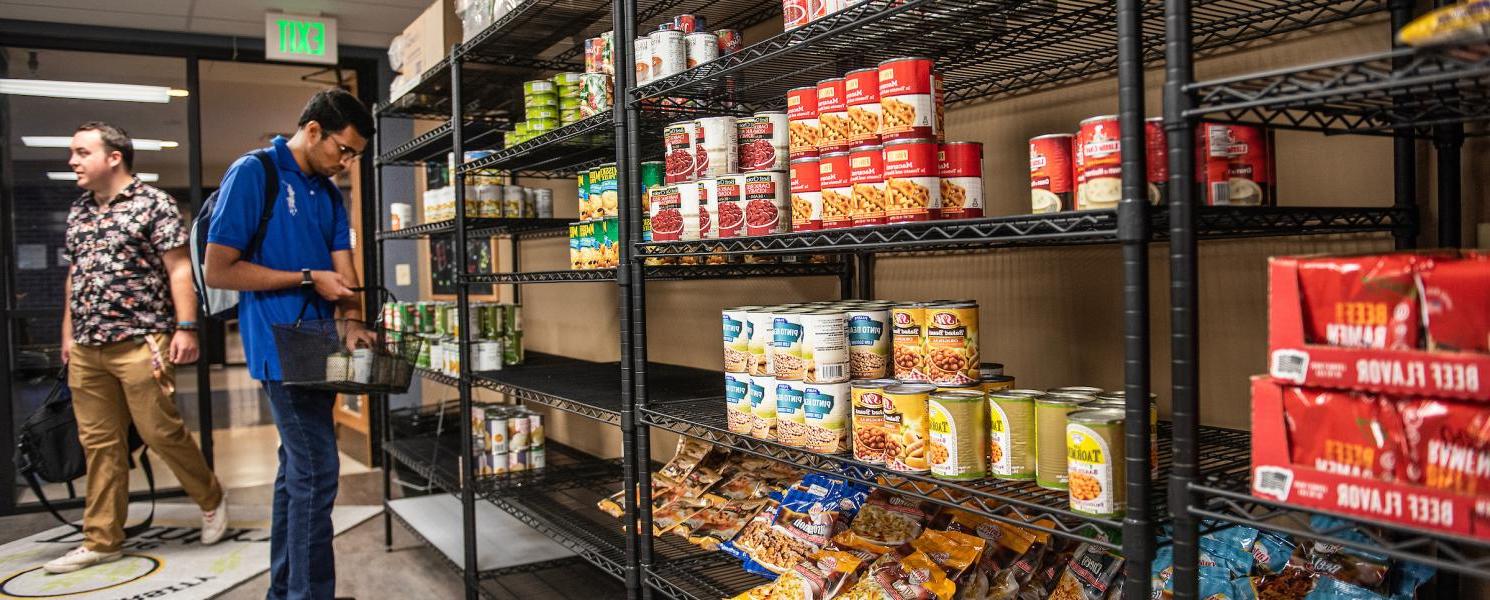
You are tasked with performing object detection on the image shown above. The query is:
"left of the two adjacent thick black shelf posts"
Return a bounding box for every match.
[1113,0,1155,599]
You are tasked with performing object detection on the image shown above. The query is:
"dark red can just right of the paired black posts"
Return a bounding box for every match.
[1196,124,1274,207]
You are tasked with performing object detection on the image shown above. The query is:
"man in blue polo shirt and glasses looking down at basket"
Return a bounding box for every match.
[206,89,375,600]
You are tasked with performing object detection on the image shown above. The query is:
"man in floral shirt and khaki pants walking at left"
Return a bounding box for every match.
[45,122,228,573]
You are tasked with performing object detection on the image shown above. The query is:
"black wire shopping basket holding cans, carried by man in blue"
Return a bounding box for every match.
[274,287,419,395]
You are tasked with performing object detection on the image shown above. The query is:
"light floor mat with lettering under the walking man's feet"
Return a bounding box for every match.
[0,503,381,600]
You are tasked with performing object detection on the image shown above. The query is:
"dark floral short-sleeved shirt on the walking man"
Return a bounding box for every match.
[64,179,186,345]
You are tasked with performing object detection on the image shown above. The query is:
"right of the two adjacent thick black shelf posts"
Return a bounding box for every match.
[1156,0,1199,600]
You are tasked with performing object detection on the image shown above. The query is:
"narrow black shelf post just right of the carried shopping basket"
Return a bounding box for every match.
[450,45,478,600]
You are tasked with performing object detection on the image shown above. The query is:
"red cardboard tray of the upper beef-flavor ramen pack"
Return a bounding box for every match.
[1268,256,1490,400]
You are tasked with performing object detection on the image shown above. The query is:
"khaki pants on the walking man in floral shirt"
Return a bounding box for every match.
[67,333,222,552]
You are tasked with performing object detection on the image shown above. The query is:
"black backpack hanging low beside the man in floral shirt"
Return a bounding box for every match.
[15,368,155,537]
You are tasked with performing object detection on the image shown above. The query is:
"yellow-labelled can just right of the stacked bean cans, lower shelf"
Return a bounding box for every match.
[927,392,988,481]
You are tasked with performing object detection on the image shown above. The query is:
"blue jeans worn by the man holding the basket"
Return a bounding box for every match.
[264,381,341,600]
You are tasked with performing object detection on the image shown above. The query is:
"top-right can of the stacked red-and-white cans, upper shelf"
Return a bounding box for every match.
[879,58,937,141]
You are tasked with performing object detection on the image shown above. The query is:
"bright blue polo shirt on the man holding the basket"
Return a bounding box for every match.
[207,137,352,381]
